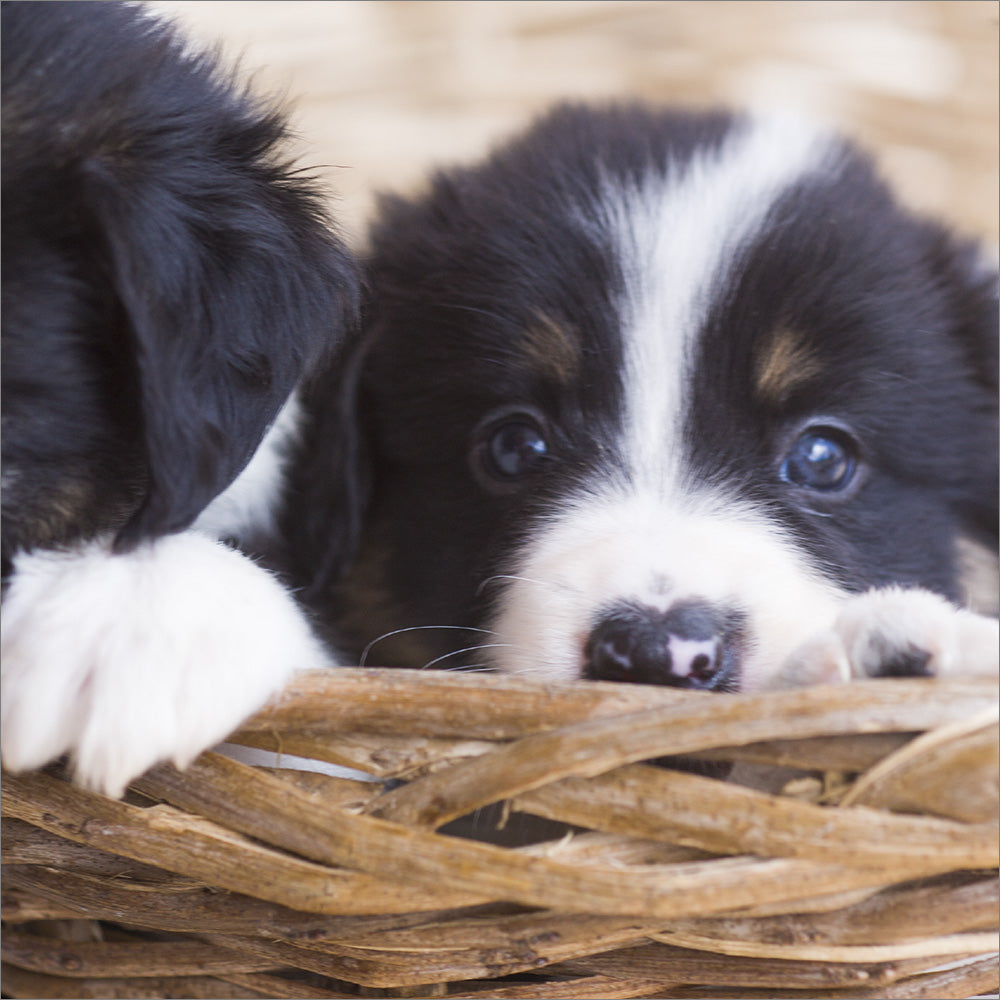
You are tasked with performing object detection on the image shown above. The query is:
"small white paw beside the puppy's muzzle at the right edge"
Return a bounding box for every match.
[776,587,1000,687]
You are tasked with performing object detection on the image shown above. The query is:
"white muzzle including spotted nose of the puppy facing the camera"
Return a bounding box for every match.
[490,494,846,691]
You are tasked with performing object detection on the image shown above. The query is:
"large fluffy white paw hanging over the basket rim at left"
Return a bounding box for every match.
[0,532,331,796]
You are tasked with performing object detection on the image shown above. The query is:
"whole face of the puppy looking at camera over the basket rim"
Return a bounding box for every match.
[341,109,997,690]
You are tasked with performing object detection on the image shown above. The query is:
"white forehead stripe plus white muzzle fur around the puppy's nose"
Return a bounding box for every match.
[491,119,842,688]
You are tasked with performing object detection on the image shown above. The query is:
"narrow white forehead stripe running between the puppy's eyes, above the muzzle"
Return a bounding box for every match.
[604,117,835,493]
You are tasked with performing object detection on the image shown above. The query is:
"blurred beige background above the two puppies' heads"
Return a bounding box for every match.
[151,0,1000,247]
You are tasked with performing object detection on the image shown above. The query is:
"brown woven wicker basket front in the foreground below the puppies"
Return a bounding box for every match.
[3,669,997,998]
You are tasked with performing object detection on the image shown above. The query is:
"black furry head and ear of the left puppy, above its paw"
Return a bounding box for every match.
[2,2,357,569]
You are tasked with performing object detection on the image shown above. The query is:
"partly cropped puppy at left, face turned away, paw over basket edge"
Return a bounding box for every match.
[2,3,357,794]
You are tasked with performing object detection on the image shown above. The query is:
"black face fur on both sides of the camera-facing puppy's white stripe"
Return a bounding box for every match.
[290,101,998,666]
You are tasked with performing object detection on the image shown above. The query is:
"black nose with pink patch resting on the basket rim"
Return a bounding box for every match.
[584,600,739,690]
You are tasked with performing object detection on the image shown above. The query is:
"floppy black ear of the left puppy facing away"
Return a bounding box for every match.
[83,123,357,550]
